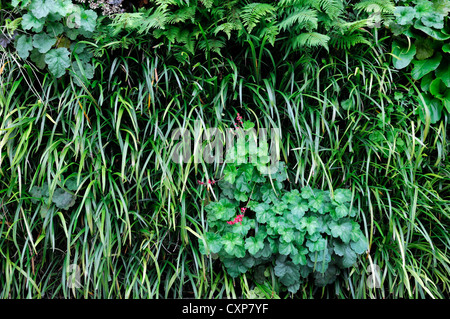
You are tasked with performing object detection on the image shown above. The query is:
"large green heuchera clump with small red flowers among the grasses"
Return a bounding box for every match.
[199,117,368,293]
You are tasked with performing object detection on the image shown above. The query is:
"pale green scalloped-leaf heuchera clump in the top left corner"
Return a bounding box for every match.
[12,0,97,85]
